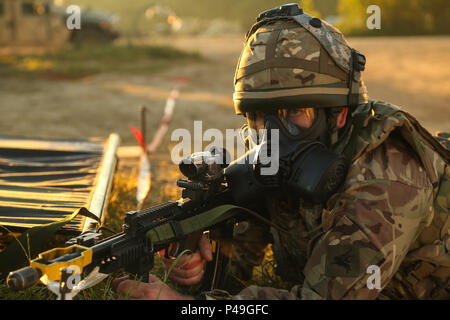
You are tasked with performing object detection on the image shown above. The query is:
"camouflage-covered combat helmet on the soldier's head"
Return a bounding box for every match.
[233,4,368,114]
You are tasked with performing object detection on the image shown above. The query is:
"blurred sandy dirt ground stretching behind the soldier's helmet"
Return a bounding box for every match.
[0,36,450,154]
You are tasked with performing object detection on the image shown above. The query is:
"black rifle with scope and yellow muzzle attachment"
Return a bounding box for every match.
[7,149,260,299]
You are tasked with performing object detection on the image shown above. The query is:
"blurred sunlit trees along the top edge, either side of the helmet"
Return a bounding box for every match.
[161,0,450,35]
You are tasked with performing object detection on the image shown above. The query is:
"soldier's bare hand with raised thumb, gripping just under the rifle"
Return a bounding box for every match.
[162,234,213,286]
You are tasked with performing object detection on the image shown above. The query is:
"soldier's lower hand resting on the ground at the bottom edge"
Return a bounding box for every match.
[112,274,194,300]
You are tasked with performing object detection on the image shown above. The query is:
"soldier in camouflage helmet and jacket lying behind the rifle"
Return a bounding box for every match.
[114,5,450,299]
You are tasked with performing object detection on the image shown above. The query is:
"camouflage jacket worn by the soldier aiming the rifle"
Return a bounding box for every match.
[207,101,450,299]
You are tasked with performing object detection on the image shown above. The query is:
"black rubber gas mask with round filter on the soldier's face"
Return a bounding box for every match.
[225,108,347,205]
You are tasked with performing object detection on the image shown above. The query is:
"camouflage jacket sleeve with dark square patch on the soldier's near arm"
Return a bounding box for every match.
[300,139,433,299]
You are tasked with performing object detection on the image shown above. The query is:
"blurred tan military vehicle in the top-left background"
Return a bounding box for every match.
[0,0,119,47]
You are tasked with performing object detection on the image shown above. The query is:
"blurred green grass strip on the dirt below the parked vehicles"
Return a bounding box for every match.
[0,44,202,79]
